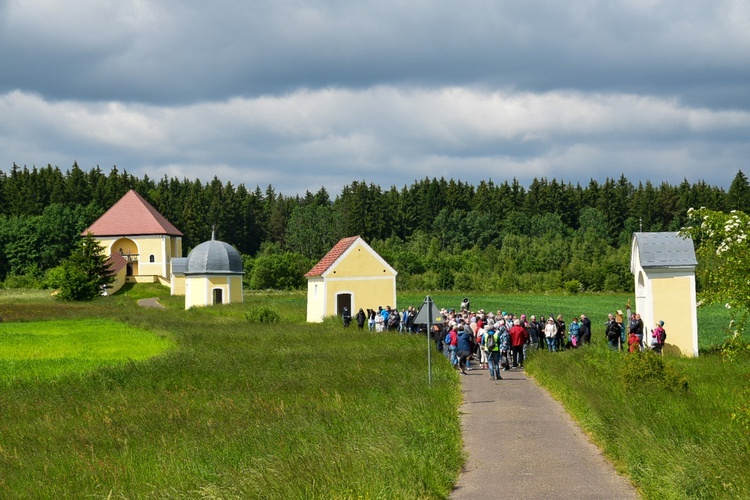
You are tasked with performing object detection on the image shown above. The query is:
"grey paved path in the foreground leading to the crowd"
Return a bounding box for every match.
[451,369,638,500]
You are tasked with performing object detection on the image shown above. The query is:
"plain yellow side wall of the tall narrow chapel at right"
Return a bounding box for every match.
[644,277,694,356]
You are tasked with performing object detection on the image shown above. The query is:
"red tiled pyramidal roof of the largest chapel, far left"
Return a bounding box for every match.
[82,189,182,236]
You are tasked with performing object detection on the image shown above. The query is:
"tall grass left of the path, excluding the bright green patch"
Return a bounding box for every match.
[0,290,463,498]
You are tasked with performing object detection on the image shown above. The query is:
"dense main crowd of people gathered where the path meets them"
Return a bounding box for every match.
[433,298,591,380]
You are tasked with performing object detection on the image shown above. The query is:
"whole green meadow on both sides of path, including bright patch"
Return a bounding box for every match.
[0,285,750,499]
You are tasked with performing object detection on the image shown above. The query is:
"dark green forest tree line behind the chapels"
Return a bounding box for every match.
[0,163,750,292]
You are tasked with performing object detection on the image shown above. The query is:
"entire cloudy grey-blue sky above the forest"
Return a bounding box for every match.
[0,0,750,195]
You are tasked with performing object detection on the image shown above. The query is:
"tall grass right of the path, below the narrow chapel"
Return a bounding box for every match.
[526,339,750,499]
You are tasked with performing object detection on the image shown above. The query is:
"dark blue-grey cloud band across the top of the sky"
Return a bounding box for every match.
[0,1,750,107]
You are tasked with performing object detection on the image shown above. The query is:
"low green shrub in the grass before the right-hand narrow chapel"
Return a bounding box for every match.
[619,351,688,391]
